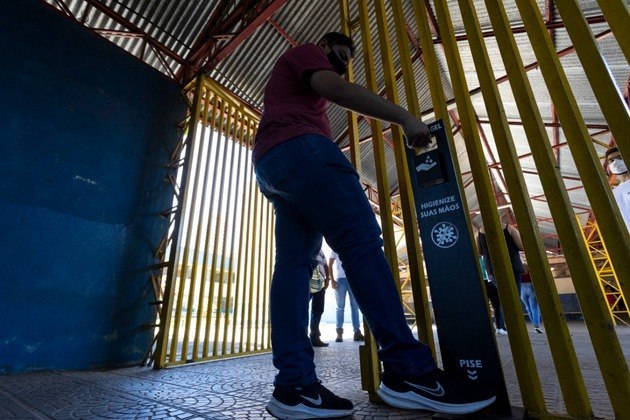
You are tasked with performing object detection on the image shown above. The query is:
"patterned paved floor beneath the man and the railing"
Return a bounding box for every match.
[0,322,630,419]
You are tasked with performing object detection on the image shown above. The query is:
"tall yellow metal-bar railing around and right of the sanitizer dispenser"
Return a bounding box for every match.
[346,0,630,418]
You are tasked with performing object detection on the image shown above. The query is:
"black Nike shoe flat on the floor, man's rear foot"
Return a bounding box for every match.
[266,381,354,419]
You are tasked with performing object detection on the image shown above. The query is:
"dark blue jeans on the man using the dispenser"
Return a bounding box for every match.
[255,135,435,385]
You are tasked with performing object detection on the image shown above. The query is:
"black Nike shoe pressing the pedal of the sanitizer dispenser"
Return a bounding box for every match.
[376,369,496,414]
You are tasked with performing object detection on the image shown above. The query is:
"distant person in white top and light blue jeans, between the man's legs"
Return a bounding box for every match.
[328,251,365,343]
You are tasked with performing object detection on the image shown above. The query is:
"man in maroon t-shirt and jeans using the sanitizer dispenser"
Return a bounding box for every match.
[252,32,496,418]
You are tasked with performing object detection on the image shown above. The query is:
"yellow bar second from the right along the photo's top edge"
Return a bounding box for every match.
[555,0,630,161]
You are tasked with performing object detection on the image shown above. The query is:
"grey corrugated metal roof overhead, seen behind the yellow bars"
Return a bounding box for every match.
[45,0,629,246]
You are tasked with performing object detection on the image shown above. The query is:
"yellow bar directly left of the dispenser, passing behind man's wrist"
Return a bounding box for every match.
[388,0,436,358]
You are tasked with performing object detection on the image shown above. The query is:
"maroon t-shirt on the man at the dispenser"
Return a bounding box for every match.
[252,44,335,163]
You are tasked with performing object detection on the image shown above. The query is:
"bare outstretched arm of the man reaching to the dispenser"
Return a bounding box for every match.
[311,70,431,147]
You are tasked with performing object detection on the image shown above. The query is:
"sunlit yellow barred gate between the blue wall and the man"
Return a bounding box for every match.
[154,76,274,367]
